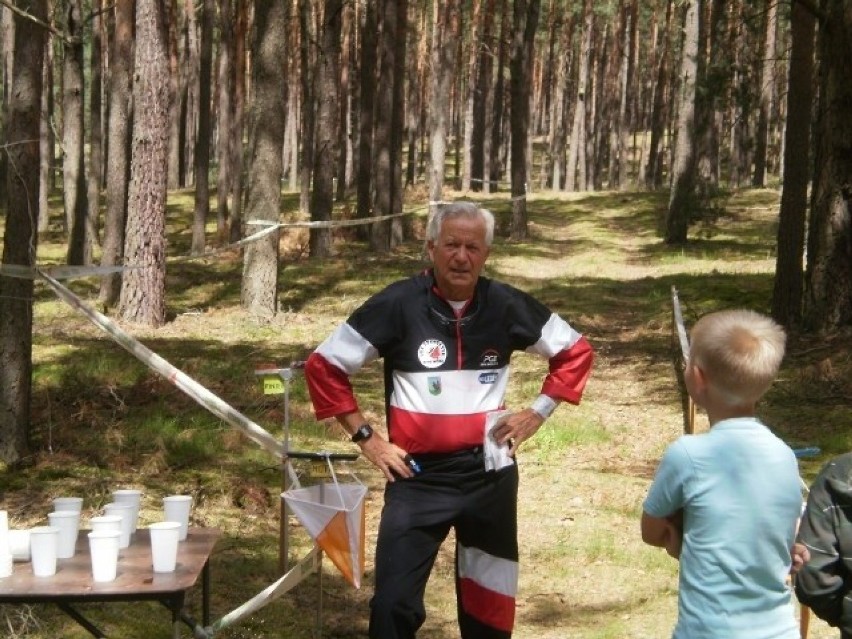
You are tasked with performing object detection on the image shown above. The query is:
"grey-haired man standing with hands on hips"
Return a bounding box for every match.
[305,202,593,639]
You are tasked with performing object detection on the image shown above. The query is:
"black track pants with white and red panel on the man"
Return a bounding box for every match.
[370,449,518,639]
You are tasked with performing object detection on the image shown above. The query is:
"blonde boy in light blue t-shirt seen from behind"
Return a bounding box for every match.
[641,310,802,639]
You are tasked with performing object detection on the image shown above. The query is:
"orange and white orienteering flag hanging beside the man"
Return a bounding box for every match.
[282,482,367,588]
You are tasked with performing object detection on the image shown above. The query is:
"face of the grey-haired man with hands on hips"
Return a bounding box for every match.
[427,217,490,302]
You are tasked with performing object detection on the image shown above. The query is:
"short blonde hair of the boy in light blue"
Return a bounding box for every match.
[689,309,786,406]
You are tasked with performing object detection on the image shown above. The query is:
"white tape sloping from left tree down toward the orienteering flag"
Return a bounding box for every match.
[38,270,284,459]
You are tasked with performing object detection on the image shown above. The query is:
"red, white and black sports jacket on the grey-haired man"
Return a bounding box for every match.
[305,270,593,453]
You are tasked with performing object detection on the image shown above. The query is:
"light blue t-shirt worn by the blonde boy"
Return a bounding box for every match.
[643,418,802,639]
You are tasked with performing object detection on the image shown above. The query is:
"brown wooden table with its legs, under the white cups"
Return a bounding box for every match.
[0,528,221,638]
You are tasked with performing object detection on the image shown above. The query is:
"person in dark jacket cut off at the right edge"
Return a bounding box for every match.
[795,453,852,639]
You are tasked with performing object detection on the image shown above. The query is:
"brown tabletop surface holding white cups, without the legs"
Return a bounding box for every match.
[0,528,221,603]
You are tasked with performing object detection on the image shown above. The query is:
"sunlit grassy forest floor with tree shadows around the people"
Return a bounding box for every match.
[0,190,852,639]
